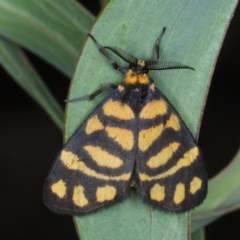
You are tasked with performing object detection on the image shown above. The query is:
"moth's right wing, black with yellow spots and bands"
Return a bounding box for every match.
[136,89,207,212]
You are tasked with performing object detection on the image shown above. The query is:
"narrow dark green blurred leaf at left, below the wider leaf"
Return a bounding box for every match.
[0,37,63,128]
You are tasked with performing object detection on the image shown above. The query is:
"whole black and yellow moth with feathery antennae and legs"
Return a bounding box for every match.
[44,28,207,215]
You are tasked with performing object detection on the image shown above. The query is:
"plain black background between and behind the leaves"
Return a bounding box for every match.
[0,0,240,240]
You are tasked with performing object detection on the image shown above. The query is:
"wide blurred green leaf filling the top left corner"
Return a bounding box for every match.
[0,0,94,76]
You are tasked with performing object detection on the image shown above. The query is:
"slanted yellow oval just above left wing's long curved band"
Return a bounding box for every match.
[83,145,123,168]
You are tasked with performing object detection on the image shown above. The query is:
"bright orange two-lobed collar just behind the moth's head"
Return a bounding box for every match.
[124,69,150,85]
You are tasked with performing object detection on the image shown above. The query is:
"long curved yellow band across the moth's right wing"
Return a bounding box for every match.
[139,147,199,181]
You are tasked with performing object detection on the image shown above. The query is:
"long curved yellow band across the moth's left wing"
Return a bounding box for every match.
[60,150,131,181]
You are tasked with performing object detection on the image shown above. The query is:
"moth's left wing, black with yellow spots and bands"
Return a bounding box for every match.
[44,90,136,215]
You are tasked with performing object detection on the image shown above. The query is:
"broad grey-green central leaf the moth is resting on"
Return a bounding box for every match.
[65,0,237,240]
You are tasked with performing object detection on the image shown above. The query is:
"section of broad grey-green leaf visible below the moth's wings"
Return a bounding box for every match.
[75,192,187,240]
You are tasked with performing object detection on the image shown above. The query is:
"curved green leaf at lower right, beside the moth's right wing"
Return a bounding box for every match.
[192,150,240,232]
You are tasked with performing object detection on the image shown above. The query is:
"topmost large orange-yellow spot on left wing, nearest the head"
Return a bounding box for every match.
[103,99,135,120]
